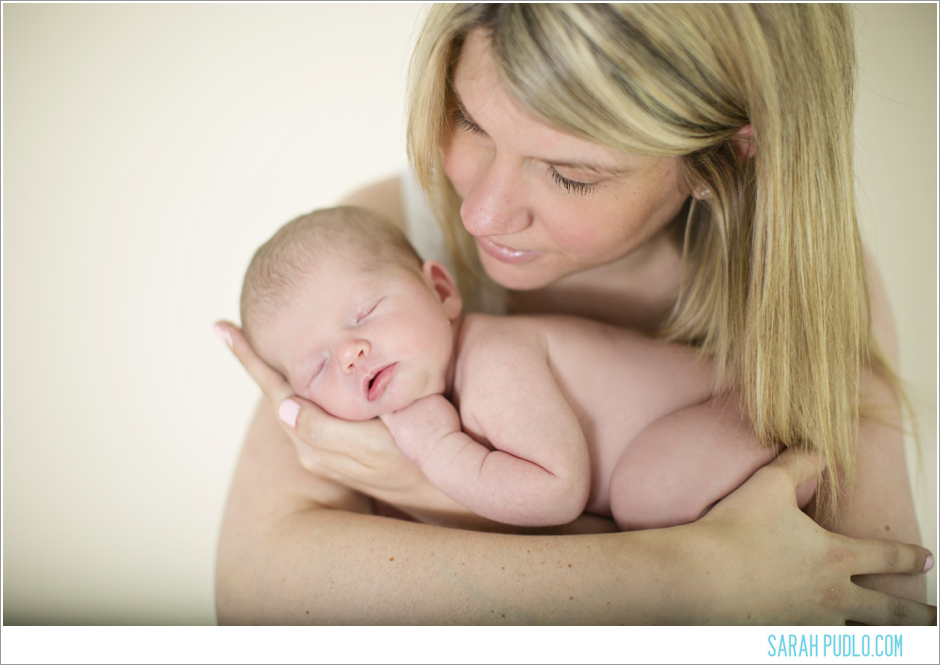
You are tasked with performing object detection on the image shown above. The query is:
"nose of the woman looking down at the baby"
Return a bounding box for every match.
[460,156,532,236]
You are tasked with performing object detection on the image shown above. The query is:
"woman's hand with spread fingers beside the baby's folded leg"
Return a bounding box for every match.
[689,451,937,625]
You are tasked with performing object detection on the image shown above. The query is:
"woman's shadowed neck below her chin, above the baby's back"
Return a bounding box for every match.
[508,227,681,331]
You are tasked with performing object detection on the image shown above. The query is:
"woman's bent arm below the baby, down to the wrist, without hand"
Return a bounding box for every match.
[216,403,691,624]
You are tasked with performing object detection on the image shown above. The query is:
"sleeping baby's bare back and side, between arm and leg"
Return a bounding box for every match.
[458,315,713,514]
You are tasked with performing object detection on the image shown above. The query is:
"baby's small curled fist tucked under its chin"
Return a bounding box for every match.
[379,395,460,465]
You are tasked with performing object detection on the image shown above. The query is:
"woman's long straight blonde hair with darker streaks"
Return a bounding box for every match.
[408,4,881,513]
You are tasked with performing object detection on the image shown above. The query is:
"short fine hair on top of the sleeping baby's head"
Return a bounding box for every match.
[240,206,421,345]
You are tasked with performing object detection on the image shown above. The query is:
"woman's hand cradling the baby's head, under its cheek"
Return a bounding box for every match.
[215,321,492,527]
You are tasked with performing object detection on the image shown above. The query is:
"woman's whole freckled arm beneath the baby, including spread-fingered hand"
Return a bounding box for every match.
[216,403,936,625]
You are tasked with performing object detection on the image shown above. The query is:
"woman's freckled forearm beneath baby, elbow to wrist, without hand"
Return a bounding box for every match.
[218,509,690,625]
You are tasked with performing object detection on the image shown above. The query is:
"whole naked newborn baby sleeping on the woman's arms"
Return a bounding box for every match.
[241,207,775,529]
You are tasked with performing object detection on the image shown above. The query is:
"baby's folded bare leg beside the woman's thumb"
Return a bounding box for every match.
[610,396,780,531]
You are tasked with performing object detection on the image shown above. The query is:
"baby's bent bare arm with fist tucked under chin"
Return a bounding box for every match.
[382,338,590,526]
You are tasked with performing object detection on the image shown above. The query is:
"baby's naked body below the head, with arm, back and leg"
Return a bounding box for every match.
[382,314,773,528]
